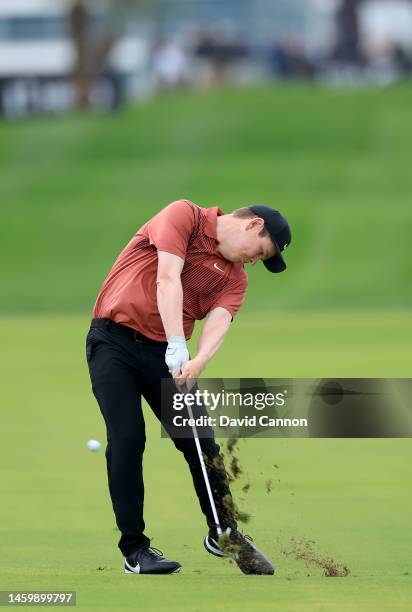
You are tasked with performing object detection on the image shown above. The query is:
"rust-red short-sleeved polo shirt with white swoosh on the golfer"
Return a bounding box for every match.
[93,200,247,341]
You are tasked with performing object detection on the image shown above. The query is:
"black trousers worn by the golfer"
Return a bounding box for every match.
[86,319,236,556]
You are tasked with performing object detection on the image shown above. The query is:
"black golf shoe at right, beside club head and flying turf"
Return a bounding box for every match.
[203,528,275,576]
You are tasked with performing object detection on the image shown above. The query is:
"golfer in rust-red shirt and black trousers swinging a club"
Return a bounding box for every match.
[86,200,291,574]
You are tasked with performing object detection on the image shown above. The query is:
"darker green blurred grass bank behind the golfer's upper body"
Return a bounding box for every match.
[0,86,412,312]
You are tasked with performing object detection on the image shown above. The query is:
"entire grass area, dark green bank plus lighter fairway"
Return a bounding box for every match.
[0,88,412,612]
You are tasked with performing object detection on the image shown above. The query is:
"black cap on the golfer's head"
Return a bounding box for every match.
[248,204,292,272]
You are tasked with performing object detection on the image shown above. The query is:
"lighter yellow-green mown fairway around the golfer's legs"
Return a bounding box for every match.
[0,312,412,612]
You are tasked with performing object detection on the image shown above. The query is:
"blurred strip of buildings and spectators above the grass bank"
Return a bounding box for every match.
[0,0,412,117]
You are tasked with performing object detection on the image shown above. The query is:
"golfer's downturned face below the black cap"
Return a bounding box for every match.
[234,218,276,266]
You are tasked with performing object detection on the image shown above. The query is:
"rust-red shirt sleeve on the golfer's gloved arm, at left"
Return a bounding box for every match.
[145,200,195,259]
